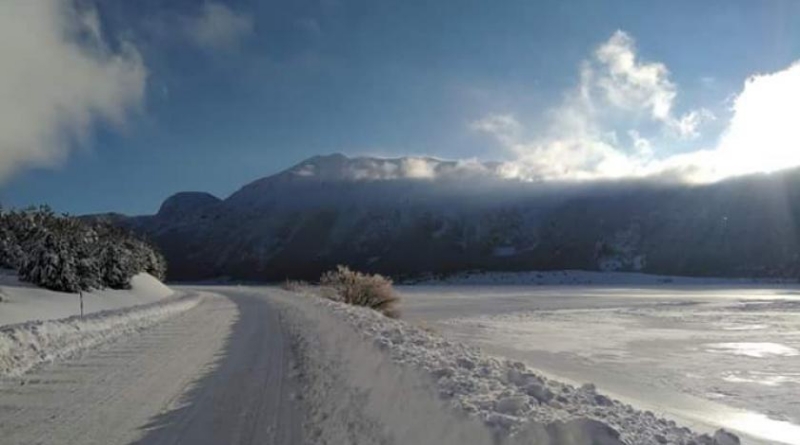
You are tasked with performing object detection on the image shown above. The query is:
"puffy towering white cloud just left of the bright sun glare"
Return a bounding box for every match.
[470,32,675,180]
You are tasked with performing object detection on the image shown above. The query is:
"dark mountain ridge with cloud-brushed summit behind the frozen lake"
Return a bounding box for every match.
[104,154,800,281]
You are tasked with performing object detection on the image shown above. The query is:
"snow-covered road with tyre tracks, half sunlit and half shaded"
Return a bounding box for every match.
[0,288,308,445]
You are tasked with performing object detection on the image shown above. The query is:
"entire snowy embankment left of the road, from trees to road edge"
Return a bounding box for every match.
[0,268,200,376]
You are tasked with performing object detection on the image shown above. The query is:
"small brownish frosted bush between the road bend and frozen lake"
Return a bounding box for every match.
[320,266,400,318]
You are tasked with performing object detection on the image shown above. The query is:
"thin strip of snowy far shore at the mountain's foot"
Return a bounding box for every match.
[412,270,797,286]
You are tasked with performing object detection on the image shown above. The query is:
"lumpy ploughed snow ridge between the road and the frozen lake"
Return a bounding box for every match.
[311,292,739,445]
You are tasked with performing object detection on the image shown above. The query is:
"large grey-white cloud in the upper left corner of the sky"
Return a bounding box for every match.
[0,0,147,181]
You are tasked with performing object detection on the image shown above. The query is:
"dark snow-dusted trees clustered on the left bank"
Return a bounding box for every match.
[0,207,166,292]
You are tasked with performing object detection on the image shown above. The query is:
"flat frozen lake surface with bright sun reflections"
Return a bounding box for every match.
[399,284,800,444]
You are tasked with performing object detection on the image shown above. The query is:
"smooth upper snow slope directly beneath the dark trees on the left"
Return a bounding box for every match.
[0,269,173,326]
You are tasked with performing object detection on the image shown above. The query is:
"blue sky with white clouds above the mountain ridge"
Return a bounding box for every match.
[0,0,800,214]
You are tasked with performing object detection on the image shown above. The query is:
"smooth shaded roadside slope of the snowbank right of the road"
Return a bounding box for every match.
[272,289,496,445]
